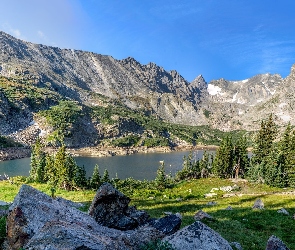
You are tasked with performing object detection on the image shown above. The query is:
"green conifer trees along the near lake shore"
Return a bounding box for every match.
[29,115,295,190]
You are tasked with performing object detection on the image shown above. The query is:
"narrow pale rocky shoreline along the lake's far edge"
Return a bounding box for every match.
[0,145,218,161]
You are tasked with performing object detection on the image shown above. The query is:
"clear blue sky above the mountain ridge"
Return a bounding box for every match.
[0,0,295,81]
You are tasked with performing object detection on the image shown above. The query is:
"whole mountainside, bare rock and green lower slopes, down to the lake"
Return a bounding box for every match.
[0,32,295,146]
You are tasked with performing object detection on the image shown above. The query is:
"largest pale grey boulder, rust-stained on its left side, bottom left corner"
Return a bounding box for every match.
[4,185,164,250]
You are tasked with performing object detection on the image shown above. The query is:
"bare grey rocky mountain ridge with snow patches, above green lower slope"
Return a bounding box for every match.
[0,32,295,146]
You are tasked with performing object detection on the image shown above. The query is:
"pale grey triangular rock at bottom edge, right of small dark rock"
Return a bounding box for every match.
[162,221,232,250]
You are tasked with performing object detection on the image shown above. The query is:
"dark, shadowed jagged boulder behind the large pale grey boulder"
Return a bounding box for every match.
[89,183,149,230]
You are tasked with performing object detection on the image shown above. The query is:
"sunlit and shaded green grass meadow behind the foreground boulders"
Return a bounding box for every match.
[0,178,295,249]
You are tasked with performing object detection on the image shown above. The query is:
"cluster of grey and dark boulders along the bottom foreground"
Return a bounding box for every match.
[2,183,288,250]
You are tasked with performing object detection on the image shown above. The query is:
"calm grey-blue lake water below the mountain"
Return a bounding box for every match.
[0,150,213,180]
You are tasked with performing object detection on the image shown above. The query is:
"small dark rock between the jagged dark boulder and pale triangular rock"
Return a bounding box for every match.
[149,214,181,235]
